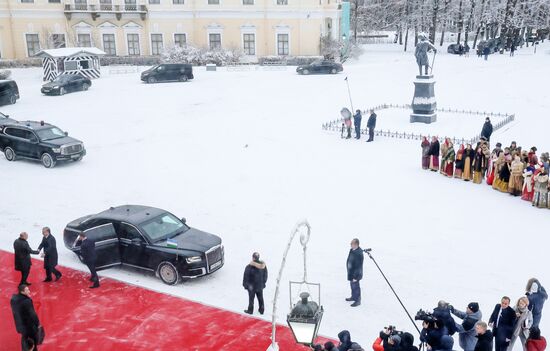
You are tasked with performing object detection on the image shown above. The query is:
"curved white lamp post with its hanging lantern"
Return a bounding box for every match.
[267,221,323,351]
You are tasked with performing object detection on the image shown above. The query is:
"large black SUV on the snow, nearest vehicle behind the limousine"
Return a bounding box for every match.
[0,118,86,168]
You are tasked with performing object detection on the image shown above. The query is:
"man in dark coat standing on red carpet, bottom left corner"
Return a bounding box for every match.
[10,284,40,351]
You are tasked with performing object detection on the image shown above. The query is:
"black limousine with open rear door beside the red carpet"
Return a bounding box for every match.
[63,205,224,285]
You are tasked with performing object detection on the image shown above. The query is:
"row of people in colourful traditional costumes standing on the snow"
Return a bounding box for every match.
[421,136,550,208]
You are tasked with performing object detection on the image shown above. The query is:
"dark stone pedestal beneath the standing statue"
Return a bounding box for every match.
[410,75,437,124]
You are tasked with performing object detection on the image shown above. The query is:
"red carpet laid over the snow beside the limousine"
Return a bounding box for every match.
[0,250,332,351]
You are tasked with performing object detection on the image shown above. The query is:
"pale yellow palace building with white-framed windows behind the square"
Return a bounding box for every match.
[0,0,341,59]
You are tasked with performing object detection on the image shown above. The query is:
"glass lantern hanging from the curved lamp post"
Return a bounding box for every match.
[286,292,323,346]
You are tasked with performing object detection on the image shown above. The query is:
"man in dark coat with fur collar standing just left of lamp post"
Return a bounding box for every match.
[243,252,267,314]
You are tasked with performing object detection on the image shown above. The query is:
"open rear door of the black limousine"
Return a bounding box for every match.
[75,223,121,270]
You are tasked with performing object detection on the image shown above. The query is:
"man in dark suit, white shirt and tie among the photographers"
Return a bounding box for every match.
[489,296,516,351]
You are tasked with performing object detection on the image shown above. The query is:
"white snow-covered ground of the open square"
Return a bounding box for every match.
[0,43,550,350]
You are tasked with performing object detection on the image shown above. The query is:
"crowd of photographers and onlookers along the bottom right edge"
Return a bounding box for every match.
[313,278,548,351]
